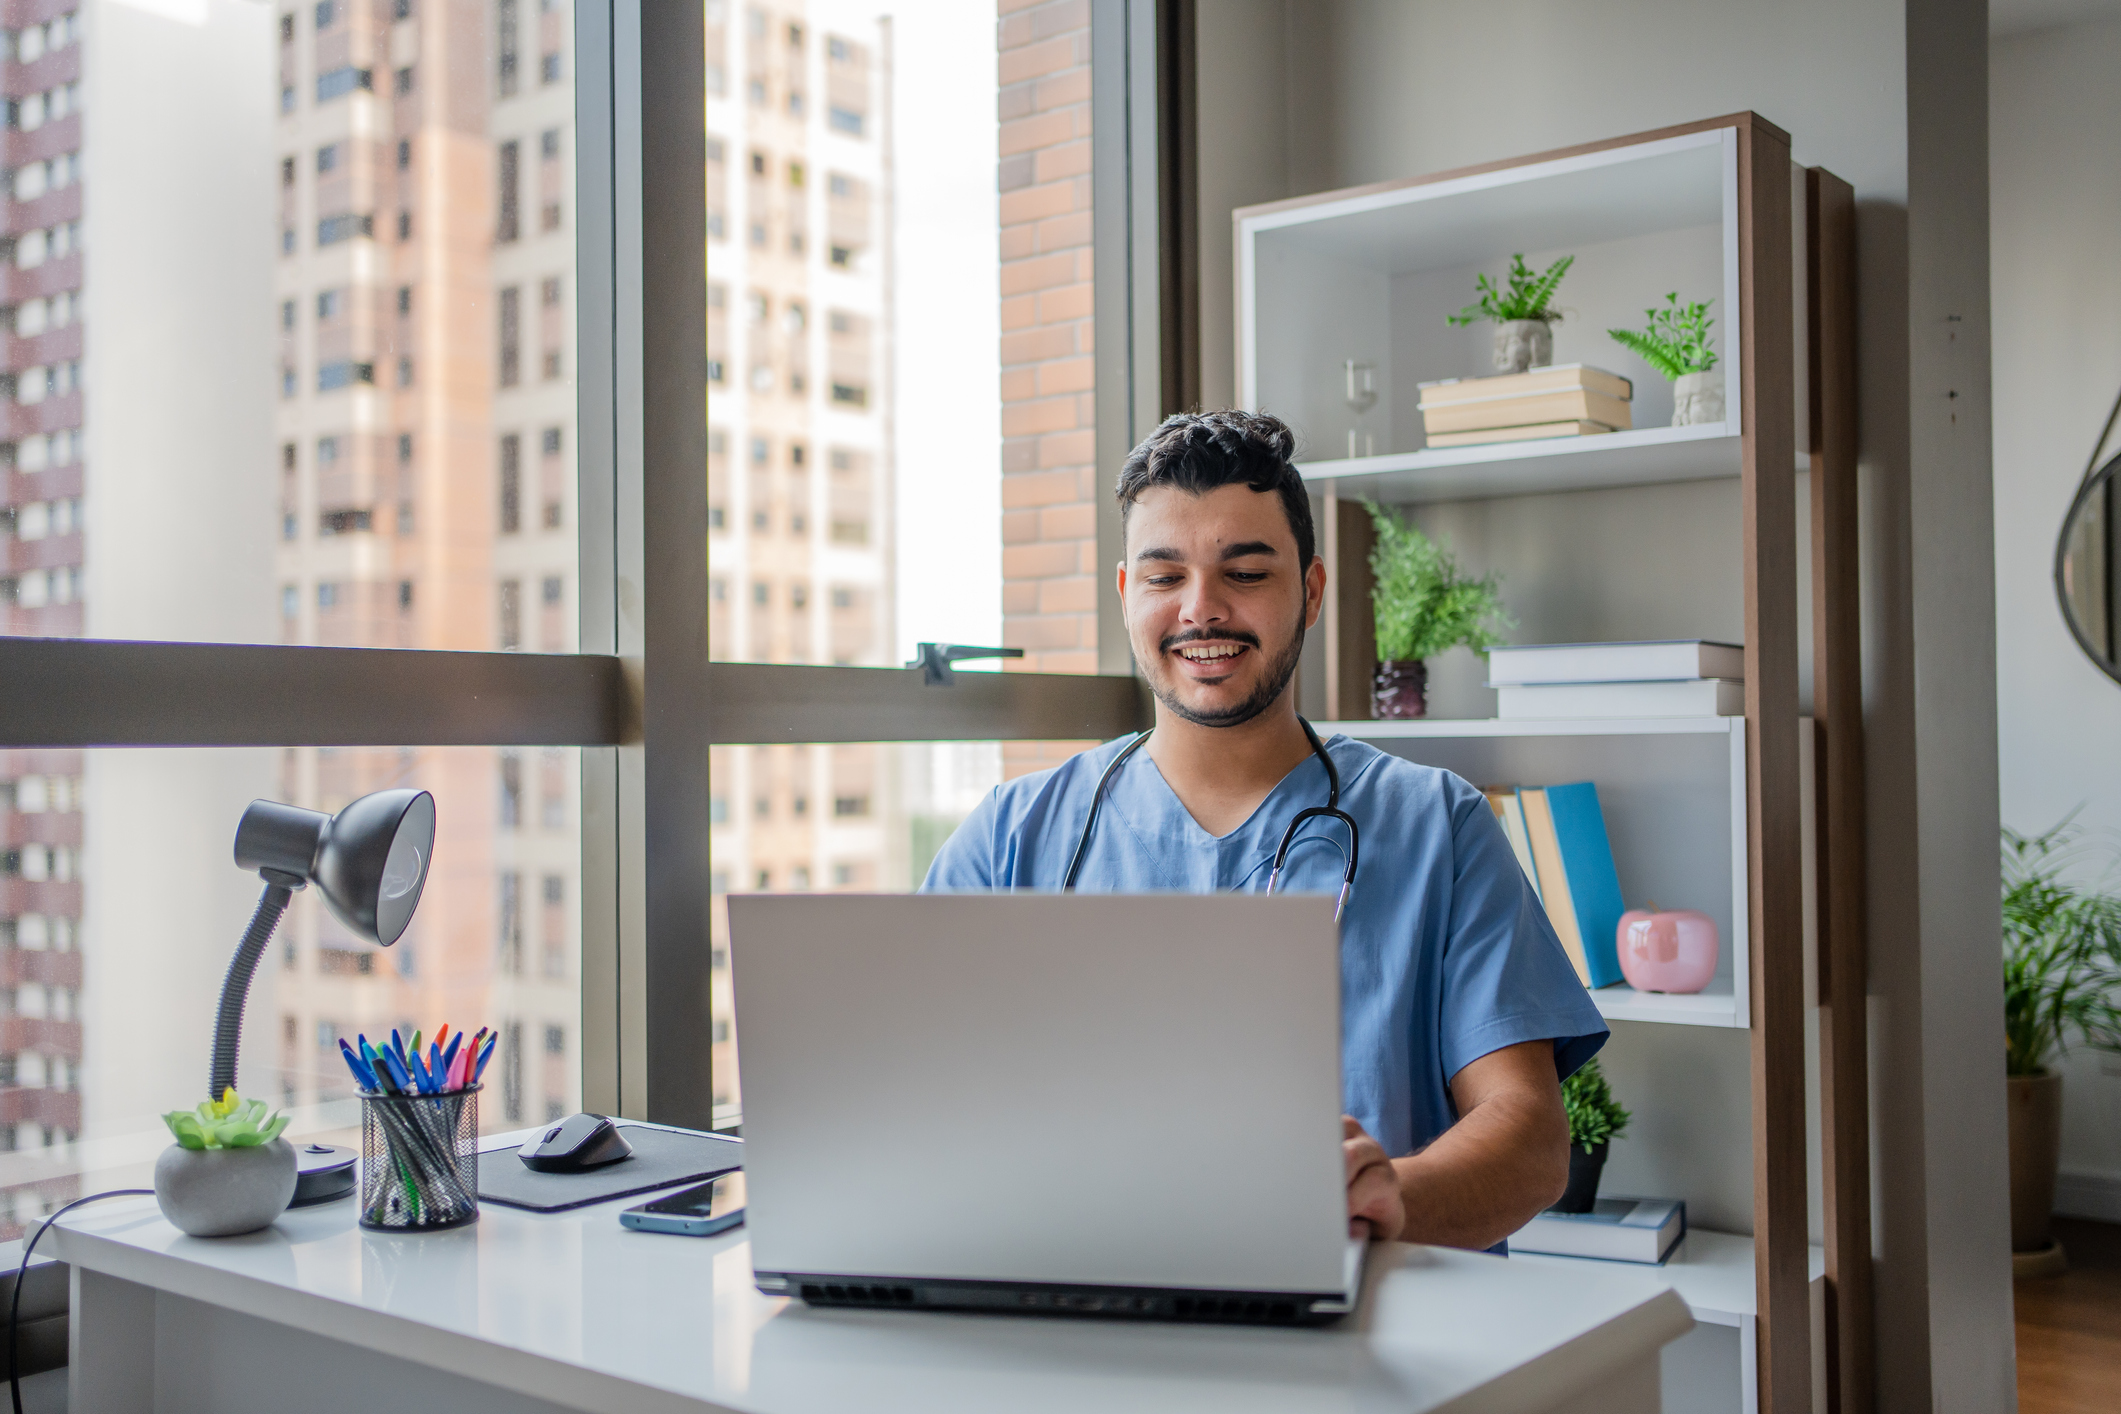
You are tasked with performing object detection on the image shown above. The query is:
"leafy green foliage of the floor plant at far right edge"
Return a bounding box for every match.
[2002,820,2121,1075]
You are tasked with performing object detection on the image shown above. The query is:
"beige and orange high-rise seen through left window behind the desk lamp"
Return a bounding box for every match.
[274,0,579,1128]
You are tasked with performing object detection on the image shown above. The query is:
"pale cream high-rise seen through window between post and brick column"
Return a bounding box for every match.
[706,0,886,1104]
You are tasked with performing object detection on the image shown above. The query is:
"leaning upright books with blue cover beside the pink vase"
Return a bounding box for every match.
[1487,780,1627,988]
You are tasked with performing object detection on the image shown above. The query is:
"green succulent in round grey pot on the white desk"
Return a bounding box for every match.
[155,1088,295,1238]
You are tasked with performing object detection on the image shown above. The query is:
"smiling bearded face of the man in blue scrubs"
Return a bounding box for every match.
[1120,483,1326,727]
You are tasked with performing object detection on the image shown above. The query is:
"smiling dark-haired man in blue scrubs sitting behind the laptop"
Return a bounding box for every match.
[925,411,1606,1247]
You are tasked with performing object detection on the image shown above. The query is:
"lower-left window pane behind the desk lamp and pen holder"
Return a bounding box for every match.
[0,746,581,1240]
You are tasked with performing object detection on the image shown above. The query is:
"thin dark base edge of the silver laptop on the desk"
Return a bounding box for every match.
[757,1272,1351,1325]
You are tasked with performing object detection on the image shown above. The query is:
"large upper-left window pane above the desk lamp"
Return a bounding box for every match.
[0,0,577,651]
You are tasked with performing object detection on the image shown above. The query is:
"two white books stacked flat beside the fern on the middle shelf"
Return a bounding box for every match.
[1487,638,1746,719]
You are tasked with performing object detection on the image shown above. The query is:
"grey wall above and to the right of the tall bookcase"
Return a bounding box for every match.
[1198,0,2013,1410]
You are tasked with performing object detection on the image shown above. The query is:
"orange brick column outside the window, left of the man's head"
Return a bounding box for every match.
[997,0,1109,776]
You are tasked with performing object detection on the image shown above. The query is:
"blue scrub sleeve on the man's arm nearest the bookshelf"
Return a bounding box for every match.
[1440,782,1610,1083]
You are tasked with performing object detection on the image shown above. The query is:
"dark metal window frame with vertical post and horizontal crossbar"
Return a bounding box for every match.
[0,0,1156,1128]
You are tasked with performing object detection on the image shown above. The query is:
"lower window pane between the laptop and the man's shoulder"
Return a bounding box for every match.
[708,742,1090,1109]
